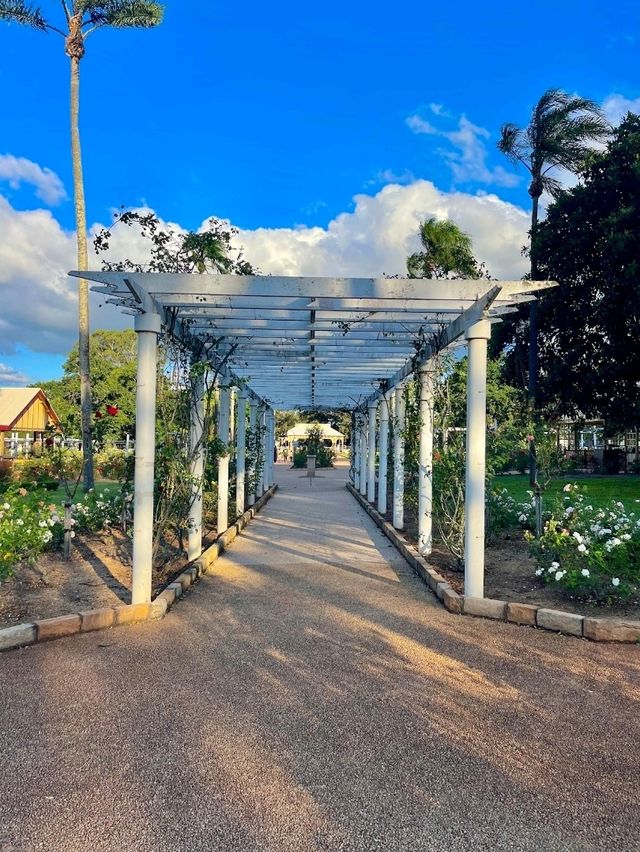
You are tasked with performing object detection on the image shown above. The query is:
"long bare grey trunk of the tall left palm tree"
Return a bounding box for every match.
[71,57,93,490]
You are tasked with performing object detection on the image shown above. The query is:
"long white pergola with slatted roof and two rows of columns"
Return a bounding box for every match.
[70,272,555,603]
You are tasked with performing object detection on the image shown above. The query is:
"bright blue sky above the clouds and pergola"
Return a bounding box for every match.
[0,0,640,383]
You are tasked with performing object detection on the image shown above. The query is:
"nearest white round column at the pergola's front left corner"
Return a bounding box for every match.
[131,313,161,604]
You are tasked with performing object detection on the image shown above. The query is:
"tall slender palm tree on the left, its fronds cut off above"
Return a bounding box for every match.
[0,0,163,489]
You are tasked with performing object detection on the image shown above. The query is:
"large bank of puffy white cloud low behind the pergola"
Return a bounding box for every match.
[0,180,529,362]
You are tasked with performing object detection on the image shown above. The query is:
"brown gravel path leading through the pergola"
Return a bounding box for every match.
[0,465,640,852]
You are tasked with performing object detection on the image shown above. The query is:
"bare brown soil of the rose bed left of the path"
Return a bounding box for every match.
[0,530,192,628]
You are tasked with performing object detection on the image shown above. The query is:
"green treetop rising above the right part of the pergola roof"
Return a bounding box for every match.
[407,217,482,278]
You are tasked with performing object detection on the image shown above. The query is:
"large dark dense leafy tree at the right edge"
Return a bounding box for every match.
[536,114,640,428]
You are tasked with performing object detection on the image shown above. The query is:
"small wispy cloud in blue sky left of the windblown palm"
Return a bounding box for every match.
[406,111,520,186]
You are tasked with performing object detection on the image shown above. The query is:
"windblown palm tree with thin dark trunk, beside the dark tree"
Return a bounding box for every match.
[498,89,611,409]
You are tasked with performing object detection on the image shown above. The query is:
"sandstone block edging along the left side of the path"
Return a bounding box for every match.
[0,485,278,651]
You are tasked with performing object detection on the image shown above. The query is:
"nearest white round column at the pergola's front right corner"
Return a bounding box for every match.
[464,320,491,598]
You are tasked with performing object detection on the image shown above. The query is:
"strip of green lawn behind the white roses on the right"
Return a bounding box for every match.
[493,474,640,513]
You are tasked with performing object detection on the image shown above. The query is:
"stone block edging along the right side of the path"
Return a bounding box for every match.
[347,482,640,642]
